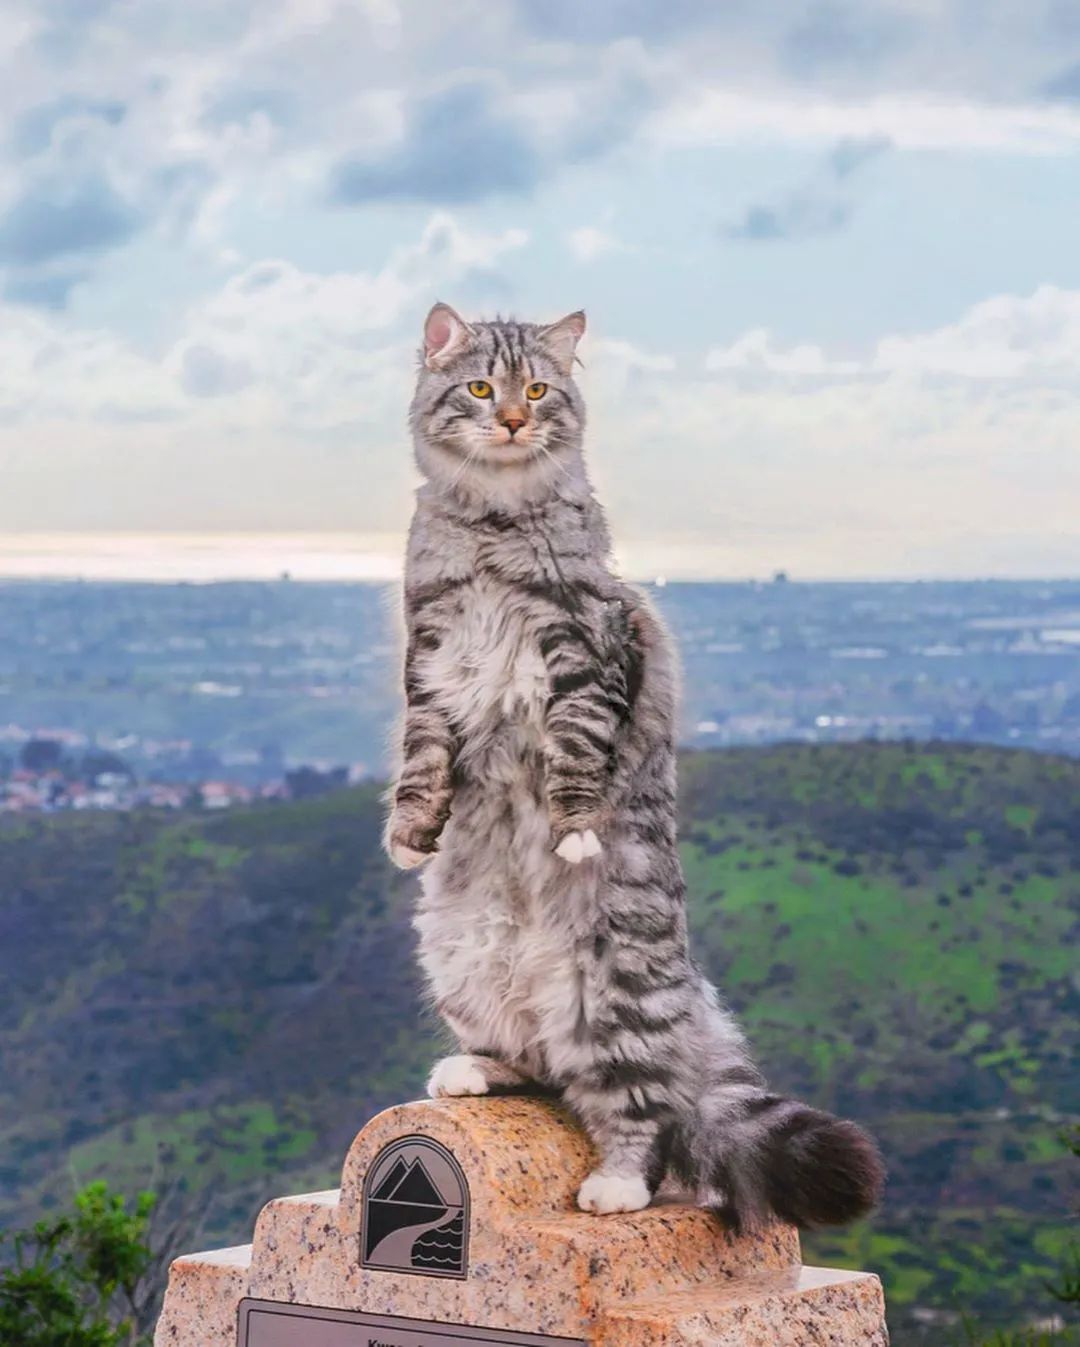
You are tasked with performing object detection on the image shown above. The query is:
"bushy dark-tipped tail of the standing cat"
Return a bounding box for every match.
[669,1086,885,1228]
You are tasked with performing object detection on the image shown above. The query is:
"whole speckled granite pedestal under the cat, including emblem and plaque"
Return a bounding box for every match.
[155,1098,889,1347]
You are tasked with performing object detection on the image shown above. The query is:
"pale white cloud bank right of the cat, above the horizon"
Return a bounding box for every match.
[600,287,1080,575]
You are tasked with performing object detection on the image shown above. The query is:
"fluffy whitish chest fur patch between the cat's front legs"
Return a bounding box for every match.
[428,581,548,730]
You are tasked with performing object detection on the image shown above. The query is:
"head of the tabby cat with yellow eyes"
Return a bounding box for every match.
[409,304,584,506]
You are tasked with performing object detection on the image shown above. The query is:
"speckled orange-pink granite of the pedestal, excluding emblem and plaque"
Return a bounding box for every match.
[155,1098,887,1347]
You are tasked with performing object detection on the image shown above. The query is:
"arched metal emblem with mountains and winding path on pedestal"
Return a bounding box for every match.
[360,1137,469,1277]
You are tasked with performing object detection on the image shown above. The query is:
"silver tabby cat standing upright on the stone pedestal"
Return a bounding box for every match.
[386,304,882,1224]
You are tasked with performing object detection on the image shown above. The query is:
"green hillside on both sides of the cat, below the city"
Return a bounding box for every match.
[0,744,1080,1343]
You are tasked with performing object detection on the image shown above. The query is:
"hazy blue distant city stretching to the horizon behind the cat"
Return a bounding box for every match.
[0,575,1080,814]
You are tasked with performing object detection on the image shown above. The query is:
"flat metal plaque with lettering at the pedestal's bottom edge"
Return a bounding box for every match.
[237,1300,586,1347]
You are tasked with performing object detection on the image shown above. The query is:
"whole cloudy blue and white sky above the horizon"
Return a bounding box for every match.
[0,0,1080,577]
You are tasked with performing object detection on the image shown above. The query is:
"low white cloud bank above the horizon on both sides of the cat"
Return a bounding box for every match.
[0,270,1080,575]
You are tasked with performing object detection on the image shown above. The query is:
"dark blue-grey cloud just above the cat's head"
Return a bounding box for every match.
[330,82,543,205]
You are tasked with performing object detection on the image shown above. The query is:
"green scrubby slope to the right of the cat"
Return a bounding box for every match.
[683,746,1080,1316]
